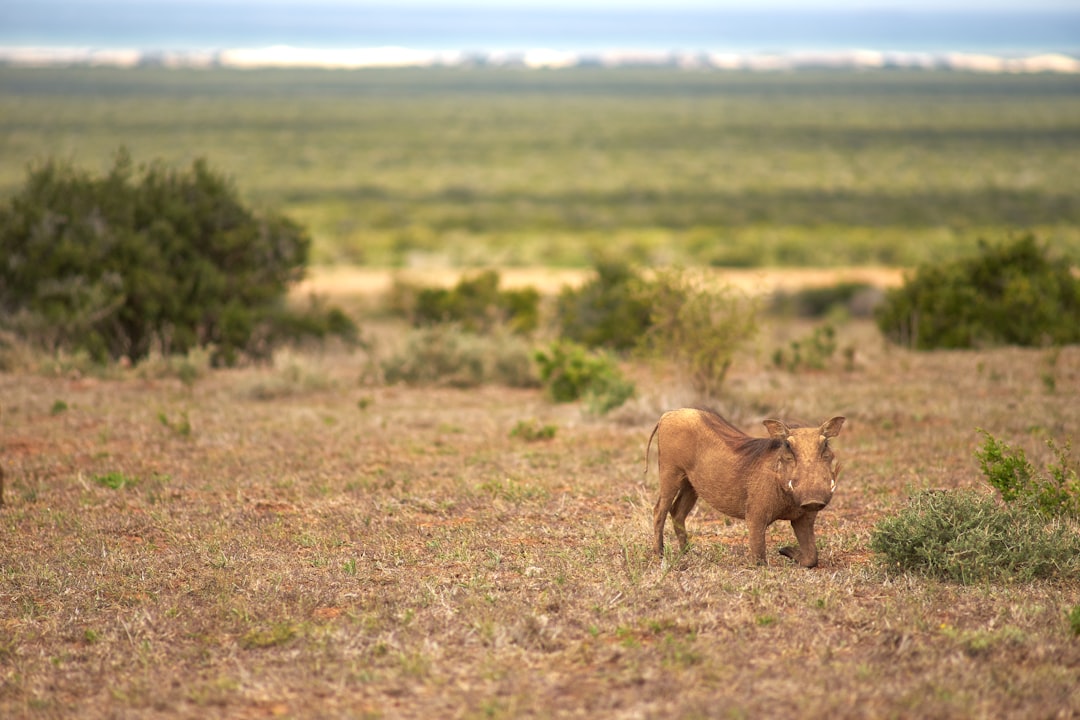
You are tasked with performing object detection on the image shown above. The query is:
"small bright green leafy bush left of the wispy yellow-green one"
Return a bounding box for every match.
[534,340,634,415]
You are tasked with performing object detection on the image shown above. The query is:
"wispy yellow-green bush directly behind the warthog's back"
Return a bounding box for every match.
[637,270,757,397]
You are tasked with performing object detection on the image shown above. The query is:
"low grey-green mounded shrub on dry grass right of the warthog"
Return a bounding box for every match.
[870,490,1080,584]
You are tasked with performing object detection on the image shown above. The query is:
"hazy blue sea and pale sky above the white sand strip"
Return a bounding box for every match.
[0,0,1080,55]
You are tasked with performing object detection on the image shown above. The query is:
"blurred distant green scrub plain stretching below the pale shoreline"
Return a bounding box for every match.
[6,67,1080,267]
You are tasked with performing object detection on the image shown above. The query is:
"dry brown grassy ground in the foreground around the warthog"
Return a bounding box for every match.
[0,322,1080,718]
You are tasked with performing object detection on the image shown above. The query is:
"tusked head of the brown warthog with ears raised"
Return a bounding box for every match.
[765,418,845,511]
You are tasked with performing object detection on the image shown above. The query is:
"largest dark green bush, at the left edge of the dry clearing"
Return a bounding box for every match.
[0,150,355,364]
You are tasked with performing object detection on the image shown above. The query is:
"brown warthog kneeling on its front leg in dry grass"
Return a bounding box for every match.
[645,408,845,568]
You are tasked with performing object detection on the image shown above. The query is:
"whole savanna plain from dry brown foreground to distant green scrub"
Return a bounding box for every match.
[0,68,1080,718]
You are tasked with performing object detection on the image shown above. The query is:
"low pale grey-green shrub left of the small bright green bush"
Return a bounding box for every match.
[382,325,538,388]
